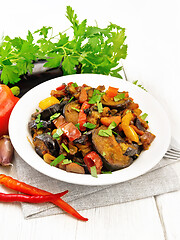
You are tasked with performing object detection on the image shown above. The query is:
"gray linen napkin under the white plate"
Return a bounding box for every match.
[14,153,180,219]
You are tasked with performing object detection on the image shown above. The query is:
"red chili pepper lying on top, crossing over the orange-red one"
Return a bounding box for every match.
[0,191,68,203]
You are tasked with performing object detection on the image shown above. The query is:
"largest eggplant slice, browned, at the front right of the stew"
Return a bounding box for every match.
[92,126,132,171]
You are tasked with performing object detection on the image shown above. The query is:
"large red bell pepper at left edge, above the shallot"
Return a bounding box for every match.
[0,84,19,136]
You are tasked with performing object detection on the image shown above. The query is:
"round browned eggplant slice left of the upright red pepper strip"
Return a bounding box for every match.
[63,101,80,125]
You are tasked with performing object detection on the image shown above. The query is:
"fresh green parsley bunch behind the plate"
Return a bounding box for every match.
[0,6,127,84]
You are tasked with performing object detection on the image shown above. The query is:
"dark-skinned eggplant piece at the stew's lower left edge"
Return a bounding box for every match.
[33,133,60,157]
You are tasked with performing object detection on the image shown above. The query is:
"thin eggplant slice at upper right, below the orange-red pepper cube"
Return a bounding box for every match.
[101,98,131,110]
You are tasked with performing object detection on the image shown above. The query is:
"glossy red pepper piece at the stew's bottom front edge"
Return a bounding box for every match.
[83,151,103,174]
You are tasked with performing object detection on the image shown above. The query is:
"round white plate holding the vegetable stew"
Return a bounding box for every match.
[9,74,171,186]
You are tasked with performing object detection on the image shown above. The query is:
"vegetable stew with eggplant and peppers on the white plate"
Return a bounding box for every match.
[28,82,155,177]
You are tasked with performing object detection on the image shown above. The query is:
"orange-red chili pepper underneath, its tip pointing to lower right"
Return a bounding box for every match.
[0,174,88,221]
